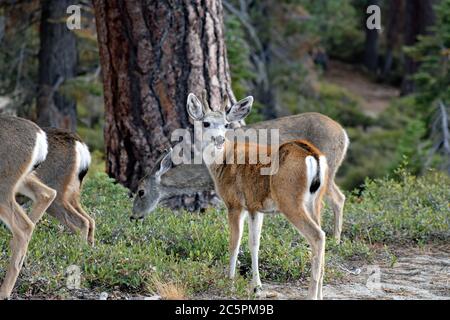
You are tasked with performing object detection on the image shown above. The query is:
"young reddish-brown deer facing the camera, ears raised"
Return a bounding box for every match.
[187,94,328,299]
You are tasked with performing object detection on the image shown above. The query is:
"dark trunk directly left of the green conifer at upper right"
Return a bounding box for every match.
[401,0,436,95]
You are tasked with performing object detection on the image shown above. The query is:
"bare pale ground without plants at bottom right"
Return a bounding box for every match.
[197,246,450,300]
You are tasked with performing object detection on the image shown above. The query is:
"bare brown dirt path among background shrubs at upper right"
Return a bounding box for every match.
[325,61,400,116]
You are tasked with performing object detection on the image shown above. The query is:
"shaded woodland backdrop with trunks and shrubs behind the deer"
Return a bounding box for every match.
[0,0,450,204]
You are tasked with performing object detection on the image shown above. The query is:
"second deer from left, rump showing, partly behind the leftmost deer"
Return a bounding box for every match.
[21,128,95,245]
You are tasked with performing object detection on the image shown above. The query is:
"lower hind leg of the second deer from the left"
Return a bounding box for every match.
[47,199,89,241]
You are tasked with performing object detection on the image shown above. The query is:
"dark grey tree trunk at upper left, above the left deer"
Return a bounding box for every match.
[37,0,77,131]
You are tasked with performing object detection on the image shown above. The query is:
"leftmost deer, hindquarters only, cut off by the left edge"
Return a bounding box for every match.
[0,116,56,299]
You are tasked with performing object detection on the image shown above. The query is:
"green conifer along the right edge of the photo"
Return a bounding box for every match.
[407,0,450,173]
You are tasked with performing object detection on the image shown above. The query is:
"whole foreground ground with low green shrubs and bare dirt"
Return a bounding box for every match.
[4,173,450,300]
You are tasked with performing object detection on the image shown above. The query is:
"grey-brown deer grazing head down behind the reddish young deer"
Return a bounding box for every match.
[132,99,349,242]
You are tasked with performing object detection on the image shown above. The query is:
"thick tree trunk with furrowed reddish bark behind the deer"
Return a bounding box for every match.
[93,0,234,199]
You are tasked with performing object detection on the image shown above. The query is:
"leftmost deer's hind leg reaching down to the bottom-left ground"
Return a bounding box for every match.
[0,200,34,300]
